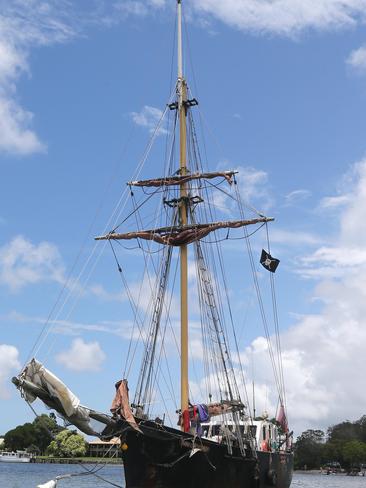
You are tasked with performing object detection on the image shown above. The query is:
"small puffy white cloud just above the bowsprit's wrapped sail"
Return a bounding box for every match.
[56,338,106,371]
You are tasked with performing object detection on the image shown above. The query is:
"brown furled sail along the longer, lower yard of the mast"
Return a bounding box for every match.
[95,217,273,246]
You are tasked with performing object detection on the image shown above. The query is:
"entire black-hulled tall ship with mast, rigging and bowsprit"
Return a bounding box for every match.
[13,0,293,488]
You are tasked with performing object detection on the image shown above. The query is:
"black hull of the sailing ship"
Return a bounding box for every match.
[121,422,293,488]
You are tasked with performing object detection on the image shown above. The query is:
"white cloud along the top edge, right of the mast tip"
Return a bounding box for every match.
[190,0,366,36]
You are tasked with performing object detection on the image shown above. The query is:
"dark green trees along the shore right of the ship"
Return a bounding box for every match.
[294,415,366,469]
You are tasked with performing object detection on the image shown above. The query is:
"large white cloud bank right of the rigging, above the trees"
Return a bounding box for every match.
[245,160,366,433]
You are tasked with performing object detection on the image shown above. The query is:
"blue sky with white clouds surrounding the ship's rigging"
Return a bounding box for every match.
[0,0,366,433]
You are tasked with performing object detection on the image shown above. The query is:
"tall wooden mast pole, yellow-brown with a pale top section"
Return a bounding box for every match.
[177,0,188,430]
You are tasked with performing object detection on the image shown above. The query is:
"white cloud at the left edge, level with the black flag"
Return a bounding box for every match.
[0,236,64,291]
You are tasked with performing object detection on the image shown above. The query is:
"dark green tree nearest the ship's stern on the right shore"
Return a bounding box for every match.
[294,429,325,469]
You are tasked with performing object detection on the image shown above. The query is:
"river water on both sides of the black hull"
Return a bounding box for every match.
[0,463,366,488]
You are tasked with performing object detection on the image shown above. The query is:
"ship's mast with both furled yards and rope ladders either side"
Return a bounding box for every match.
[95,0,273,430]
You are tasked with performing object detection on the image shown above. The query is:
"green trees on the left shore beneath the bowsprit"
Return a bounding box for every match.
[3,413,87,457]
